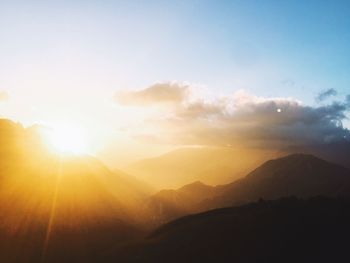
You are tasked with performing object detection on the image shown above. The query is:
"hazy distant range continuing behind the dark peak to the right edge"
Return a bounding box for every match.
[123,142,350,190]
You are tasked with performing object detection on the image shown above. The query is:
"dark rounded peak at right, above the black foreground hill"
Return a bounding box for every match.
[202,154,350,209]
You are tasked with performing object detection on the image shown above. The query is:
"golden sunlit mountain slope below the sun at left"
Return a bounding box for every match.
[0,120,149,263]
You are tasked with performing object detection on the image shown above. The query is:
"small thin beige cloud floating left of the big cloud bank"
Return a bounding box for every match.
[114,82,190,106]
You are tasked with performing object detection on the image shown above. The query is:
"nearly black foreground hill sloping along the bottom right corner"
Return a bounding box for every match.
[111,197,350,263]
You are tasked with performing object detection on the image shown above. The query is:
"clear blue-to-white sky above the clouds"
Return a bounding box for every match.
[0,0,350,164]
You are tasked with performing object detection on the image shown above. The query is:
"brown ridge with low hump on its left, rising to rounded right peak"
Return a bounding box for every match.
[148,154,350,223]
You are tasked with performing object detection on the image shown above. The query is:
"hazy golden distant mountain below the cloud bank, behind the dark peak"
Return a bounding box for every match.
[124,147,282,190]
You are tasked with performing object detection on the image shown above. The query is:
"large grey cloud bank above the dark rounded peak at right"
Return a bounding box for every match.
[168,94,349,148]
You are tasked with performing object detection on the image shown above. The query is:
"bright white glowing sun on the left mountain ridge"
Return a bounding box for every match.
[46,123,89,154]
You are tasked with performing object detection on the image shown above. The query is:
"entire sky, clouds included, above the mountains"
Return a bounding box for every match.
[0,0,350,167]
